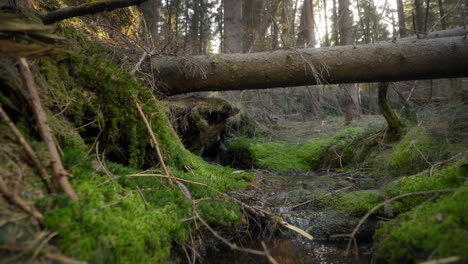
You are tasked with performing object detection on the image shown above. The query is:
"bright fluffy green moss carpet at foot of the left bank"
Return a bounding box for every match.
[42,150,250,263]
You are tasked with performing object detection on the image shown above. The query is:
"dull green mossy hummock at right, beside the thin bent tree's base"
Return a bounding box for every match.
[388,127,448,175]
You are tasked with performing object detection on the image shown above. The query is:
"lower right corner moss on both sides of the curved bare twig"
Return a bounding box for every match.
[374,156,468,263]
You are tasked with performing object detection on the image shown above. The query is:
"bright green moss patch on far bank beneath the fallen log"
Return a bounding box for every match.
[228,127,371,173]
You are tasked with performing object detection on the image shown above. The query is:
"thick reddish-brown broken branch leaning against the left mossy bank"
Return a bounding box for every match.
[19,58,78,201]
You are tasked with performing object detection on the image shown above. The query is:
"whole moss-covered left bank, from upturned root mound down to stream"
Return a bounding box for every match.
[6,28,253,263]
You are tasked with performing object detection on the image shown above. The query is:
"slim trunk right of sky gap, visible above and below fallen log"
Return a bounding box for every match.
[338,0,359,124]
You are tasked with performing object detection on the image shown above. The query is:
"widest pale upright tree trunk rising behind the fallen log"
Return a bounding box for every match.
[224,0,242,53]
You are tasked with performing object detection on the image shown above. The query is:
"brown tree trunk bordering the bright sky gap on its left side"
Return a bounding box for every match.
[297,0,315,48]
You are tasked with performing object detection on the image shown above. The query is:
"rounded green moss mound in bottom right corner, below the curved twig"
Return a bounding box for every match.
[374,188,468,263]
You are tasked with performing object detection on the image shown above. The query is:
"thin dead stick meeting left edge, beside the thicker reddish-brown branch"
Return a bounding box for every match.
[0,105,55,192]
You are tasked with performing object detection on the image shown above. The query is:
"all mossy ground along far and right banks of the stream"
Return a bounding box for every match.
[226,116,468,263]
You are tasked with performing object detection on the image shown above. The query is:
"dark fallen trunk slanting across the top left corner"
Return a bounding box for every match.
[41,0,146,25]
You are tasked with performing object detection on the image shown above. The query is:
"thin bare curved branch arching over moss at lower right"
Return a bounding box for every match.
[331,186,460,255]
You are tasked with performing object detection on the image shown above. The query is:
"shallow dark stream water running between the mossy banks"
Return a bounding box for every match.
[207,172,378,264]
